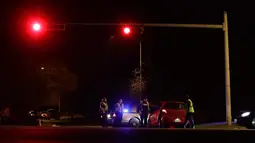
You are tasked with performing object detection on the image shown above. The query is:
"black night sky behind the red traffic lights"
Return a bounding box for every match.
[0,0,255,120]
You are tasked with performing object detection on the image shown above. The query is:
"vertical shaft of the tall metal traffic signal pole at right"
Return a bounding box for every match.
[223,12,232,125]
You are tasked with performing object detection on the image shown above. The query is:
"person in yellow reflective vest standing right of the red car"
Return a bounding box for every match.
[184,95,195,128]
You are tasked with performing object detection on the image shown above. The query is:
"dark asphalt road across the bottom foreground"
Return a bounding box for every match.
[0,126,255,143]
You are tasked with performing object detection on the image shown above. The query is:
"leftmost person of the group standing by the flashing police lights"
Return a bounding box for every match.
[99,97,108,127]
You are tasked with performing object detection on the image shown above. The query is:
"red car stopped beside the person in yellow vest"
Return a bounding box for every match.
[148,101,186,128]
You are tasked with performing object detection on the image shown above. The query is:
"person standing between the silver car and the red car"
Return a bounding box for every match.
[140,98,150,127]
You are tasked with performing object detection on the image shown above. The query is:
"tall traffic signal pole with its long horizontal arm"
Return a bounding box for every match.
[65,12,232,125]
